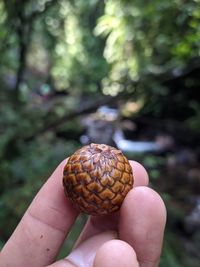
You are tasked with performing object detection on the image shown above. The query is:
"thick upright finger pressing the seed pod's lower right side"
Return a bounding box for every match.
[119,186,166,267]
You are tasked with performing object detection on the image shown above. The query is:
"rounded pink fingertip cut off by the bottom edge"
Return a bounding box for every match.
[94,240,139,267]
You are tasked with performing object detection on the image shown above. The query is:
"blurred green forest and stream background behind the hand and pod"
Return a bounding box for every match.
[0,0,200,267]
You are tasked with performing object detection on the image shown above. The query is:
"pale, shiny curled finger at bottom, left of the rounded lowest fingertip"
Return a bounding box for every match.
[48,231,117,267]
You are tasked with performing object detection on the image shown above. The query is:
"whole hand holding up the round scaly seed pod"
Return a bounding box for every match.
[0,161,166,267]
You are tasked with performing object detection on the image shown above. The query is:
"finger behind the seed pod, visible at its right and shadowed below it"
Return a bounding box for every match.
[75,161,149,246]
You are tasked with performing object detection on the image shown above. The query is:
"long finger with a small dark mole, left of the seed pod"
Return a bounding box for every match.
[0,160,78,267]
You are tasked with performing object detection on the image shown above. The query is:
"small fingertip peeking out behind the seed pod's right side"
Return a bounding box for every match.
[129,160,149,187]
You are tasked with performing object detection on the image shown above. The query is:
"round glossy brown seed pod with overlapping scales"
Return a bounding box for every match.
[63,144,133,215]
